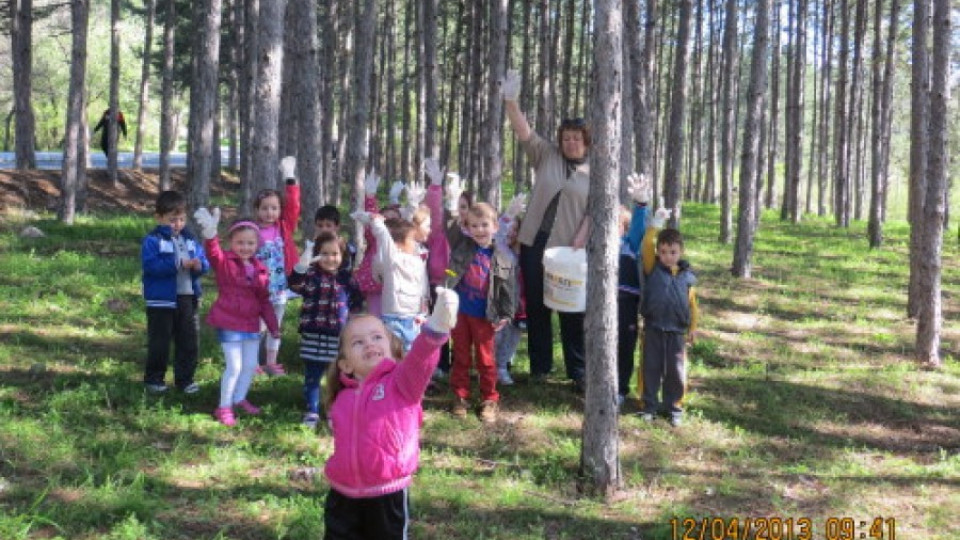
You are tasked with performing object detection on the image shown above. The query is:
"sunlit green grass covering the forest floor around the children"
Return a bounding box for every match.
[0,204,960,540]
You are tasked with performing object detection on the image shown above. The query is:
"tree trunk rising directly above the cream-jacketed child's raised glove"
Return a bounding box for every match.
[344,0,377,213]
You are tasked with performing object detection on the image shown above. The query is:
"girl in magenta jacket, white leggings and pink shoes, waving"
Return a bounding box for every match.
[194,208,280,426]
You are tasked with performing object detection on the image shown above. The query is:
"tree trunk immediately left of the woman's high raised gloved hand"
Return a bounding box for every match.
[477,0,510,208]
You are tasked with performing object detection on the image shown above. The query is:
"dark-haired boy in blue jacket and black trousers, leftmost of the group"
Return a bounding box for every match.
[140,191,210,394]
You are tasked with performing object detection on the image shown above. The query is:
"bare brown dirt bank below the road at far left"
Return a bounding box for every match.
[0,169,239,214]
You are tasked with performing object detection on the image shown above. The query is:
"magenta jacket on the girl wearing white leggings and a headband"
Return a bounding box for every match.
[203,238,280,333]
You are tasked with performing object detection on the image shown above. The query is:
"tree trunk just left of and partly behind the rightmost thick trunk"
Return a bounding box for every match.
[907,0,930,317]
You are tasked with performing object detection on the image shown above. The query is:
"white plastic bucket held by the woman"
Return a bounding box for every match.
[543,246,587,312]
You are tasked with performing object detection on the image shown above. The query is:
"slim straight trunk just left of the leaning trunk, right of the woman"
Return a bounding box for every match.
[720,0,738,244]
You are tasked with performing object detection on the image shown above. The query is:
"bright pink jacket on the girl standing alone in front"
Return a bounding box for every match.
[324,327,448,498]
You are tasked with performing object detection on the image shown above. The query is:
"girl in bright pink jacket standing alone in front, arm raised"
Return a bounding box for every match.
[324,288,459,539]
